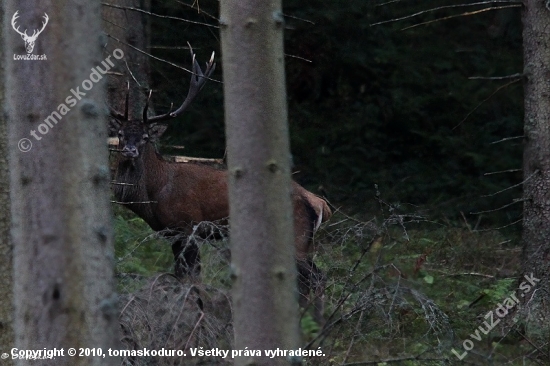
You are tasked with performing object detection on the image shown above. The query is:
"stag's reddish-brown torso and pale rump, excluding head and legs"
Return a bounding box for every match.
[114,143,331,266]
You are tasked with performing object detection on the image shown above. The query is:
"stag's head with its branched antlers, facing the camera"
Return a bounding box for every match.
[109,47,216,159]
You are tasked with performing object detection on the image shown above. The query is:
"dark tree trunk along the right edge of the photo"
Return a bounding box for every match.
[522,0,550,341]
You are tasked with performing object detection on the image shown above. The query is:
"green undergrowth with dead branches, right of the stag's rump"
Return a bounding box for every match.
[292,200,528,365]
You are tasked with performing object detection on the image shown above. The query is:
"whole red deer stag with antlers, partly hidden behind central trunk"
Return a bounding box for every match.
[110,51,332,319]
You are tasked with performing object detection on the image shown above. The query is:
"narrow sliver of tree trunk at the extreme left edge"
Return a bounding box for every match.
[0,3,13,354]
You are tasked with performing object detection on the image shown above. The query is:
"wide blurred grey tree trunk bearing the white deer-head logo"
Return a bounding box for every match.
[4,0,120,365]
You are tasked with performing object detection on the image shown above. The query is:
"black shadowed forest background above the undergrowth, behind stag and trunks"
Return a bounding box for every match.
[149,0,523,227]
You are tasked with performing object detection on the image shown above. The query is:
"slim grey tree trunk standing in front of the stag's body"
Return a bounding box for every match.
[220,0,299,365]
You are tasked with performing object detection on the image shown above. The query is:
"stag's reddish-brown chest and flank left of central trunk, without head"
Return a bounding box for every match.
[115,143,229,231]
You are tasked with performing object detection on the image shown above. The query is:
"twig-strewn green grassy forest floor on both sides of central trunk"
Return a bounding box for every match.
[115,202,544,365]
